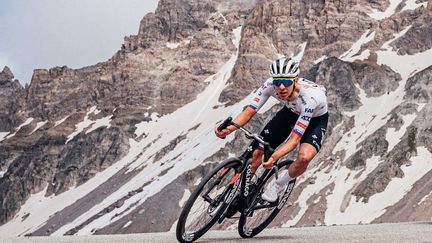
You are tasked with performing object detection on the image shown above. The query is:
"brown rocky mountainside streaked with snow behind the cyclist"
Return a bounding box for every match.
[0,0,432,235]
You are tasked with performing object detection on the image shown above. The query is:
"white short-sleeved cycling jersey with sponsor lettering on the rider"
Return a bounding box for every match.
[249,78,328,137]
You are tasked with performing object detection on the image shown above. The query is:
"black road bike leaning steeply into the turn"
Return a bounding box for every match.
[176,117,295,242]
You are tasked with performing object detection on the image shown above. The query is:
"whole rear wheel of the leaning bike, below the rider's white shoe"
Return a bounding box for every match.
[238,160,295,238]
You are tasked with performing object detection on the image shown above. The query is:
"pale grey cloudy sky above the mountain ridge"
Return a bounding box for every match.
[0,0,158,84]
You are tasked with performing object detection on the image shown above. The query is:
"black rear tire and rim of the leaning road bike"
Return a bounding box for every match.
[238,160,295,238]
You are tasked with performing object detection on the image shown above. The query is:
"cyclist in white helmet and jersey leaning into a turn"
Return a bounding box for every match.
[215,57,328,202]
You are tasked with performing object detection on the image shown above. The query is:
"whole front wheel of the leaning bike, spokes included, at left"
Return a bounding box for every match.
[176,158,241,242]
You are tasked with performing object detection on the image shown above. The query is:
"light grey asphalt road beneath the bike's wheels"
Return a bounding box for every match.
[0,222,432,243]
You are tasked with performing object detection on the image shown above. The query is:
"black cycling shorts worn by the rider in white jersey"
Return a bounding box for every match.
[260,106,328,152]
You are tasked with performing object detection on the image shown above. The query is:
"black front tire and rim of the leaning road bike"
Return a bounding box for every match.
[176,158,241,243]
